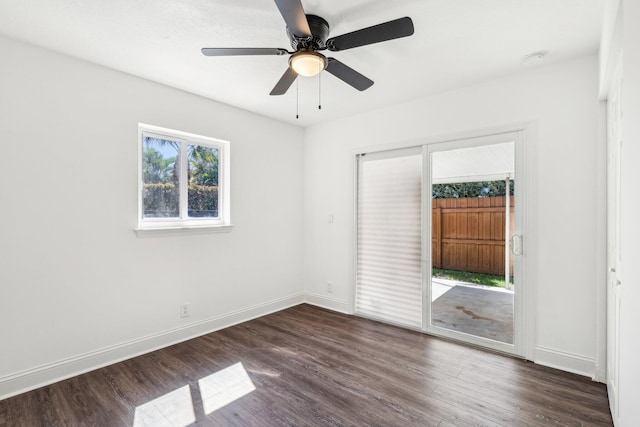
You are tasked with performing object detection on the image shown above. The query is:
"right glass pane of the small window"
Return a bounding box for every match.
[187,144,219,218]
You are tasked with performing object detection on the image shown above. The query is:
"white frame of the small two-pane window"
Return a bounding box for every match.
[136,123,231,237]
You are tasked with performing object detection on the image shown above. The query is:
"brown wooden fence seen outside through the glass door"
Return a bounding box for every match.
[432,196,514,275]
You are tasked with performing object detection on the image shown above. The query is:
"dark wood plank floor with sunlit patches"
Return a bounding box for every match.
[0,305,612,427]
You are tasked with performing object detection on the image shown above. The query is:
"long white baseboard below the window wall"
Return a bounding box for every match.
[0,293,305,400]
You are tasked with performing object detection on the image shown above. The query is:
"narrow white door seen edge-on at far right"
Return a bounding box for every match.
[607,54,622,419]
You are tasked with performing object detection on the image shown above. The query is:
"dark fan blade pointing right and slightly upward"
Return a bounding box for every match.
[327,17,413,52]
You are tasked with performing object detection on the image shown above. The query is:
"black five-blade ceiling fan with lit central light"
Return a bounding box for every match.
[202,0,413,95]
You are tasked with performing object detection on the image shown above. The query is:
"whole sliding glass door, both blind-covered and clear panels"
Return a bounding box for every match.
[355,132,524,354]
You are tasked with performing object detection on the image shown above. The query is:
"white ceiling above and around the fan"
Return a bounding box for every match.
[0,0,604,126]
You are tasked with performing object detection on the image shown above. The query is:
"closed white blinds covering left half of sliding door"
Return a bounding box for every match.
[356,155,422,328]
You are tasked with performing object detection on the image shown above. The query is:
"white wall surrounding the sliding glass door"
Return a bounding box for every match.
[304,56,605,376]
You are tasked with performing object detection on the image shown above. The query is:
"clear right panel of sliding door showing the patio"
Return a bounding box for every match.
[423,132,525,356]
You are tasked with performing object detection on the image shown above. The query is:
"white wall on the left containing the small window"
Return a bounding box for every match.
[0,38,303,399]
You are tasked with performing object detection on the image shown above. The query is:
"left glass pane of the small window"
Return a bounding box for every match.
[142,136,180,218]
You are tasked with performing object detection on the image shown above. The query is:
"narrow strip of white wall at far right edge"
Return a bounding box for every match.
[617,0,640,427]
